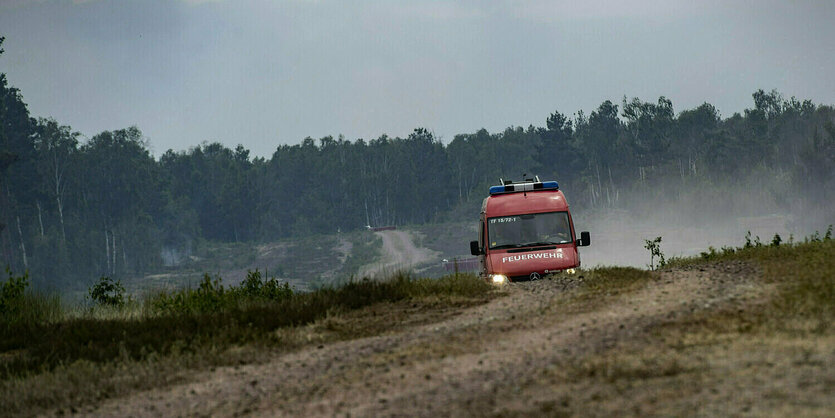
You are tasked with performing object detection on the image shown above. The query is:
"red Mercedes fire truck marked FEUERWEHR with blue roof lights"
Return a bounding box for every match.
[470,176,591,283]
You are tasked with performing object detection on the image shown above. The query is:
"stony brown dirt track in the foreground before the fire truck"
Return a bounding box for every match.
[76,264,792,416]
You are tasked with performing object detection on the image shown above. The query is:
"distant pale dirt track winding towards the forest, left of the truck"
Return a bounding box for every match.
[357,230,438,277]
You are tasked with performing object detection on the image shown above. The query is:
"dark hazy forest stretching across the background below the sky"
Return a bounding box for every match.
[0,38,835,288]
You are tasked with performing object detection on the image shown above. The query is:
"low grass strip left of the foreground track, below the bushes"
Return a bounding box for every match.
[0,274,492,414]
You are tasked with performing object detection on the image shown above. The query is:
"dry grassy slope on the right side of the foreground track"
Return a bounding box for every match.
[516,240,835,416]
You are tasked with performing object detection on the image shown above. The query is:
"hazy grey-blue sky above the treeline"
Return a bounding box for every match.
[0,0,835,156]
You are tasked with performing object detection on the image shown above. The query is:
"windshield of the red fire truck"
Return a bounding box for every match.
[487,212,571,249]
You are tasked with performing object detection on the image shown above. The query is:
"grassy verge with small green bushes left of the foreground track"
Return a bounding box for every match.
[0,270,494,413]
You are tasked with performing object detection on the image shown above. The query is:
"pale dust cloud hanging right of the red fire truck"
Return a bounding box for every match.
[566,172,835,267]
